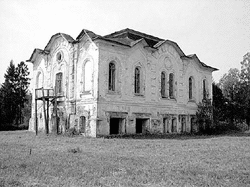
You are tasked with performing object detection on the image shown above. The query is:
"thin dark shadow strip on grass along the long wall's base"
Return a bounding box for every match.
[99,132,250,140]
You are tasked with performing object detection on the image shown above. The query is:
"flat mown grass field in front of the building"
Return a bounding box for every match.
[0,131,250,187]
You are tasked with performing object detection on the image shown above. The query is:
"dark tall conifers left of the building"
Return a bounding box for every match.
[0,61,31,130]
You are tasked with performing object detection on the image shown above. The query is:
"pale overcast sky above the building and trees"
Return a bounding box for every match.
[0,0,250,83]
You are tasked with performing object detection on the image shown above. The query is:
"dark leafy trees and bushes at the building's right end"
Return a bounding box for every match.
[196,53,250,133]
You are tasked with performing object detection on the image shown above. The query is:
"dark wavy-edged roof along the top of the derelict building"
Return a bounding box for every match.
[28,28,218,71]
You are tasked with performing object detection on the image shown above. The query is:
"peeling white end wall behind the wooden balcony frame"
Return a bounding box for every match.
[29,37,98,136]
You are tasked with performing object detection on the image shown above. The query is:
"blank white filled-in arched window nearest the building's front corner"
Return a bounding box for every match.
[84,61,93,91]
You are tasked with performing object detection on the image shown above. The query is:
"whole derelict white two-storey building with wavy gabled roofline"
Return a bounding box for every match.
[28,29,217,137]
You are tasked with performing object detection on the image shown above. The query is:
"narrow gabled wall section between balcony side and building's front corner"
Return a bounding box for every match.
[75,36,99,136]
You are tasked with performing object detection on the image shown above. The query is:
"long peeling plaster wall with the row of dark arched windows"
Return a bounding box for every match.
[97,42,212,135]
